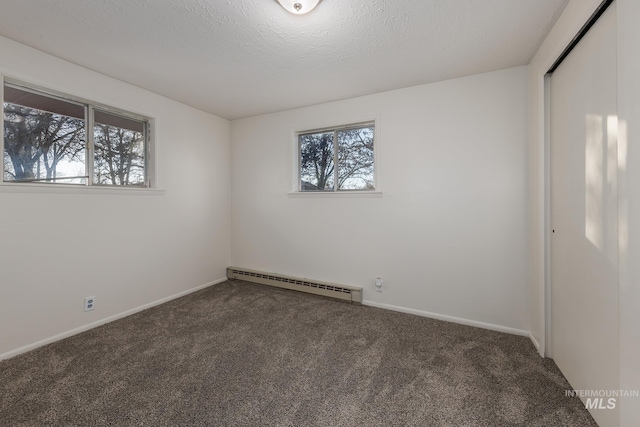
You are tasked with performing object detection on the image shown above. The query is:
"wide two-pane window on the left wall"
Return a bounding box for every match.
[3,82,150,187]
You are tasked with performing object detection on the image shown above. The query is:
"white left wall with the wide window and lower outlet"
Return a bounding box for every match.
[0,38,230,358]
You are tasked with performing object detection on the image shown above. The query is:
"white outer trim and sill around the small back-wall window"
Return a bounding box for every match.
[287,116,383,198]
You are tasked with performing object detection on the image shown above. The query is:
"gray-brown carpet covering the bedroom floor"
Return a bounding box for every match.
[0,281,596,427]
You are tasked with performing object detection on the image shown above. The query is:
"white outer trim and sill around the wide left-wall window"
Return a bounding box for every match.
[0,73,164,195]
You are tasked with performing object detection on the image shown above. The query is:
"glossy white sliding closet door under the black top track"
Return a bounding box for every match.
[550,2,619,426]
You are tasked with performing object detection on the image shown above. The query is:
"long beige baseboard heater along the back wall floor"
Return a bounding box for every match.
[227,267,362,304]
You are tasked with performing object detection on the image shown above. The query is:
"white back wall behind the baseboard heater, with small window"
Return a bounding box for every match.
[231,67,529,334]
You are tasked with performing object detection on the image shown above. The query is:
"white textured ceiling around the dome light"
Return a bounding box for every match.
[0,0,568,119]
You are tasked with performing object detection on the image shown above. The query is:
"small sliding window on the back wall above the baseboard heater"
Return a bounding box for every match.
[298,122,375,191]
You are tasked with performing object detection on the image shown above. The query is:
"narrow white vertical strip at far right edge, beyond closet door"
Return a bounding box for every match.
[617,0,640,426]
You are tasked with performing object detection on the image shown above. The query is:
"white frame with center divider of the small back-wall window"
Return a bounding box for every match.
[296,119,382,197]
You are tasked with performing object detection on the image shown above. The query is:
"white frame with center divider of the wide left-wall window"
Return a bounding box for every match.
[0,74,158,192]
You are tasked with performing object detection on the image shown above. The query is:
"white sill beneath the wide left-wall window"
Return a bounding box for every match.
[0,182,164,196]
